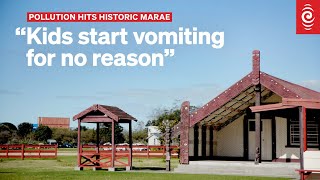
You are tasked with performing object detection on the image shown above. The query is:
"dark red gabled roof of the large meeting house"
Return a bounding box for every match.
[190,51,320,127]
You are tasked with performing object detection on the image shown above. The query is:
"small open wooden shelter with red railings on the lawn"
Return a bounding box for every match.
[73,104,137,171]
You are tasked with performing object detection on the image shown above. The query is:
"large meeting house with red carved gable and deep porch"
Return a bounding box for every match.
[178,50,320,171]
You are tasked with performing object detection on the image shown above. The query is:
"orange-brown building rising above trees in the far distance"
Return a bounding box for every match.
[38,117,70,129]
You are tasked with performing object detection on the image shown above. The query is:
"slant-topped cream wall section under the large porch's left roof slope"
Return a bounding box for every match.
[214,116,244,157]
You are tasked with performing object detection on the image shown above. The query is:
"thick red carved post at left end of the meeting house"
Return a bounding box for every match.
[180,101,190,164]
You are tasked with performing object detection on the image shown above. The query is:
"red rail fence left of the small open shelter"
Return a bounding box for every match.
[0,144,58,160]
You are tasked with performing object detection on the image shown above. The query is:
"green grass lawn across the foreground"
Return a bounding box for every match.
[0,156,290,180]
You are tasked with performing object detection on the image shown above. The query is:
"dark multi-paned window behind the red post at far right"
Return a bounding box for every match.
[288,119,319,147]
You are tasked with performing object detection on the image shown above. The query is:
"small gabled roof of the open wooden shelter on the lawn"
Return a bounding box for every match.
[73,104,136,122]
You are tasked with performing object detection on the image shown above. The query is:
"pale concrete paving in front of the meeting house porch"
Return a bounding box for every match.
[174,161,300,179]
